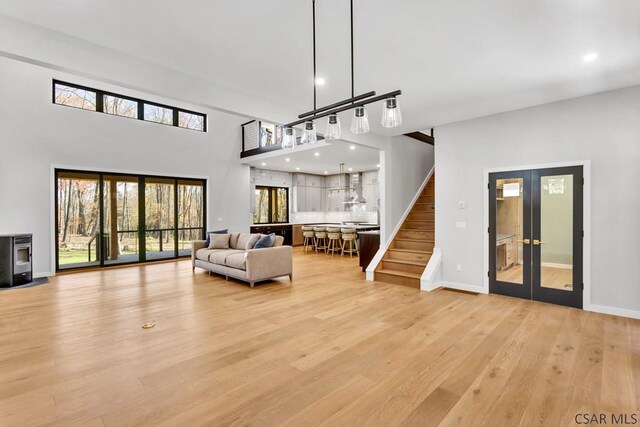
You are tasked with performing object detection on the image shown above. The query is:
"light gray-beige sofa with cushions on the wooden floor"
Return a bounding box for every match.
[191,233,293,288]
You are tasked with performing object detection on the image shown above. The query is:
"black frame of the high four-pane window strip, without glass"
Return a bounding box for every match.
[51,79,208,132]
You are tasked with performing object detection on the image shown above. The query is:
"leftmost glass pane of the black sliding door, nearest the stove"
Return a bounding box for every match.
[56,172,100,270]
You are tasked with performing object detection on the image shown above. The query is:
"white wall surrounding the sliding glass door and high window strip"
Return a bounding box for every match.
[0,57,250,275]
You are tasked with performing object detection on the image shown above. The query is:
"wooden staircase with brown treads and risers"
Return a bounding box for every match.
[374,174,436,289]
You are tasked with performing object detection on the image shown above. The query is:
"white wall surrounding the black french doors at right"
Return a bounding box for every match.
[435,86,640,314]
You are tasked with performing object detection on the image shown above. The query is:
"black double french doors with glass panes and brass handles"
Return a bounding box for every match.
[488,166,583,308]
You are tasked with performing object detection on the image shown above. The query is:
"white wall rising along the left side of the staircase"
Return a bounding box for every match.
[380,135,434,245]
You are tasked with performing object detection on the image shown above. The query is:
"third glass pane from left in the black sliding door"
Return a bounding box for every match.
[145,178,176,261]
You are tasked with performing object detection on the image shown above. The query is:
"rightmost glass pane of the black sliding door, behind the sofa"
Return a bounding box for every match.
[178,180,204,256]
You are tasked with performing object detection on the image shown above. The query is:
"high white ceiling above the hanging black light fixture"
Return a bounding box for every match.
[0,0,640,134]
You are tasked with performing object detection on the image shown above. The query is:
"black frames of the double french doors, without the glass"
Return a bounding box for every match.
[487,165,584,308]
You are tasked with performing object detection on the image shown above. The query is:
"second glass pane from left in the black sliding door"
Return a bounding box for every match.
[102,175,140,265]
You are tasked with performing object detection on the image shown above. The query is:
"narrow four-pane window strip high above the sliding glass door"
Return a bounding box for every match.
[53,80,207,132]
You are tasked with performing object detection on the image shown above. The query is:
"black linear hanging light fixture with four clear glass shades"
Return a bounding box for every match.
[285,0,402,135]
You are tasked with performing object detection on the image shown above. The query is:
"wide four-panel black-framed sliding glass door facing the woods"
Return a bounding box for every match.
[56,170,206,270]
